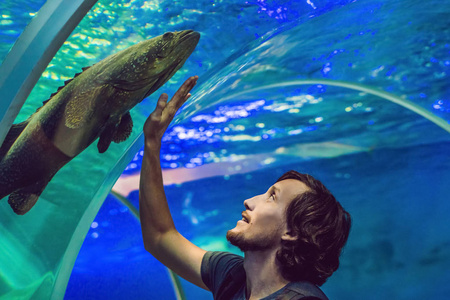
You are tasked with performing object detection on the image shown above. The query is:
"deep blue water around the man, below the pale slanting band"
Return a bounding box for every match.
[66,142,450,299]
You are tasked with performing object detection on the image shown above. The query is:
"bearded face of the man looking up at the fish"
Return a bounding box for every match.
[227,179,308,252]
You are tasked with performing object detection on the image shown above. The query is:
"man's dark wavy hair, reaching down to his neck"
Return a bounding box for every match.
[277,171,351,286]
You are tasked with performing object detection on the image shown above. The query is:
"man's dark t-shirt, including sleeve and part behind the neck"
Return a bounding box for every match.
[201,252,328,300]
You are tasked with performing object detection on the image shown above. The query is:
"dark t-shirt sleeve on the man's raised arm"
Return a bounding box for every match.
[201,251,243,295]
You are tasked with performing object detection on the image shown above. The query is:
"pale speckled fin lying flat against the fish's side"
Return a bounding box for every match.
[64,87,102,129]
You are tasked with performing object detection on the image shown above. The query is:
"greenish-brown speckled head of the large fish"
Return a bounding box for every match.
[97,30,200,105]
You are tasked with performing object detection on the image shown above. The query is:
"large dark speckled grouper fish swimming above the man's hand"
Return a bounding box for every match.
[0,30,200,215]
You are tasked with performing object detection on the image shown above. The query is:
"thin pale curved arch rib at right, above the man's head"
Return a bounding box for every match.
[221,79,450,133]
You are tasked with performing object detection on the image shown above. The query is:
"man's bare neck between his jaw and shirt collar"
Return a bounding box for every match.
[244,249,289,300]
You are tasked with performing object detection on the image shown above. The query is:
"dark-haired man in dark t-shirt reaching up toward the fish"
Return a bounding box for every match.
[139,76,351,300]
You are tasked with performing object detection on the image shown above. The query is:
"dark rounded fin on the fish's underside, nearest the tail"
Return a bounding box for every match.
[8,178,51,215]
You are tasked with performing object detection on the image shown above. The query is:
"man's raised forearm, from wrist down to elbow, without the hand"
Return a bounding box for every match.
[139,141,175,251]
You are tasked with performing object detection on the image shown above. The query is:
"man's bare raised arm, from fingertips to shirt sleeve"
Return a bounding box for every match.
[139,76,208,290]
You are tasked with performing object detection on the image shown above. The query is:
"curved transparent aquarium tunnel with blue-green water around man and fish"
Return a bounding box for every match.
[0,1,450,299]
